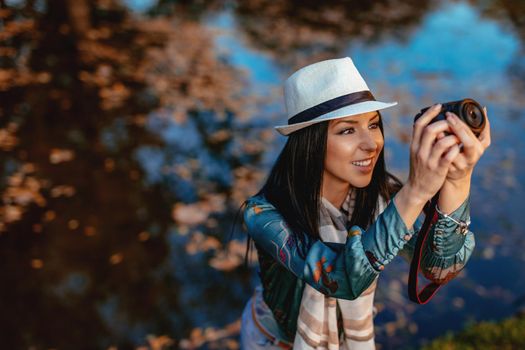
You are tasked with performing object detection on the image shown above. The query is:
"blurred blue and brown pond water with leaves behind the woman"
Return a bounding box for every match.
[0,0,525,349]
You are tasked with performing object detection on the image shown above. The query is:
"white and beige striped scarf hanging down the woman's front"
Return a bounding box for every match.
[293,191,385,350]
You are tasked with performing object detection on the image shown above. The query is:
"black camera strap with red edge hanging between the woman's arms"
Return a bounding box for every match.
[408,192,442,304]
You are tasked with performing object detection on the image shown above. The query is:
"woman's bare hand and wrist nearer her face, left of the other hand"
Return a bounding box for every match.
[394,104,460,228]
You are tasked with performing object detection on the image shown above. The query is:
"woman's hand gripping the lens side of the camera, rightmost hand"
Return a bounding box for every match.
[445,107,490,183]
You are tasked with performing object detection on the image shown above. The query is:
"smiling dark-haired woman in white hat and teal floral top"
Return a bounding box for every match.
[241,57,490,349]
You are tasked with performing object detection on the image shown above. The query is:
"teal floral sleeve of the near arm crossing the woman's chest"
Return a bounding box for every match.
[244,196,414,299]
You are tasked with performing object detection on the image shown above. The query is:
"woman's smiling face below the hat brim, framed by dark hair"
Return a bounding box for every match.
[323,112,384,188]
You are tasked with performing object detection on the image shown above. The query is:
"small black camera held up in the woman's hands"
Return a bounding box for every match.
[414,98,486,136]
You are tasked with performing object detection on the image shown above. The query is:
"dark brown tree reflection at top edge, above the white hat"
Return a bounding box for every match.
[236,0,431,67]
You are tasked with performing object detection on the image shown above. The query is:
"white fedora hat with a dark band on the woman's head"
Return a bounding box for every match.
[275,57,397,135]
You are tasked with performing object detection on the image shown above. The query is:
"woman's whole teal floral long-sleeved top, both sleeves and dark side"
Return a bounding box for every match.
[244,191,474,342]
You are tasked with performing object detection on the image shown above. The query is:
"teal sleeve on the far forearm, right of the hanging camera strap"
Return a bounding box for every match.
[400,198,475,284]
